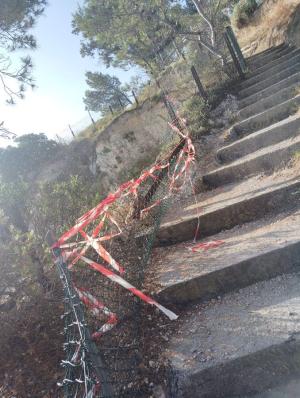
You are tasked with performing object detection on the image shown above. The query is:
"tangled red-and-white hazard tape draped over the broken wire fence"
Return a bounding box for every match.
[53,117,195,324]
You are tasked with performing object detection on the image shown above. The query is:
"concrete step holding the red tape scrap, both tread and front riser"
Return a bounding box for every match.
[150,210,300,304]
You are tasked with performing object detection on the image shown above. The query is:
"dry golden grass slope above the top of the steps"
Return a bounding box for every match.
[236,0,300,54]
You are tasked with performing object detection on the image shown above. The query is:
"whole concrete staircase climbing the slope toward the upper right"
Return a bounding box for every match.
[148,44,300,398]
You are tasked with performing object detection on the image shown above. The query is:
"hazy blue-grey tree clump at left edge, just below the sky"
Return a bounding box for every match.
[0,134,60,182]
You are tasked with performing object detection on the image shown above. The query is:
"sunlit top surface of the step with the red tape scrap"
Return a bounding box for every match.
[150,208,300,299]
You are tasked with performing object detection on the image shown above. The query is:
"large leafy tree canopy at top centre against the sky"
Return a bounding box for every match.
[73,0,184,71]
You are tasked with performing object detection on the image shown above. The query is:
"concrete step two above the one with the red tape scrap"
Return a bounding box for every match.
[203,135,300,188]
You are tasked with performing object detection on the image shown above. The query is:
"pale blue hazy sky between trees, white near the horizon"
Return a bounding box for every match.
[0,0,136,145]
